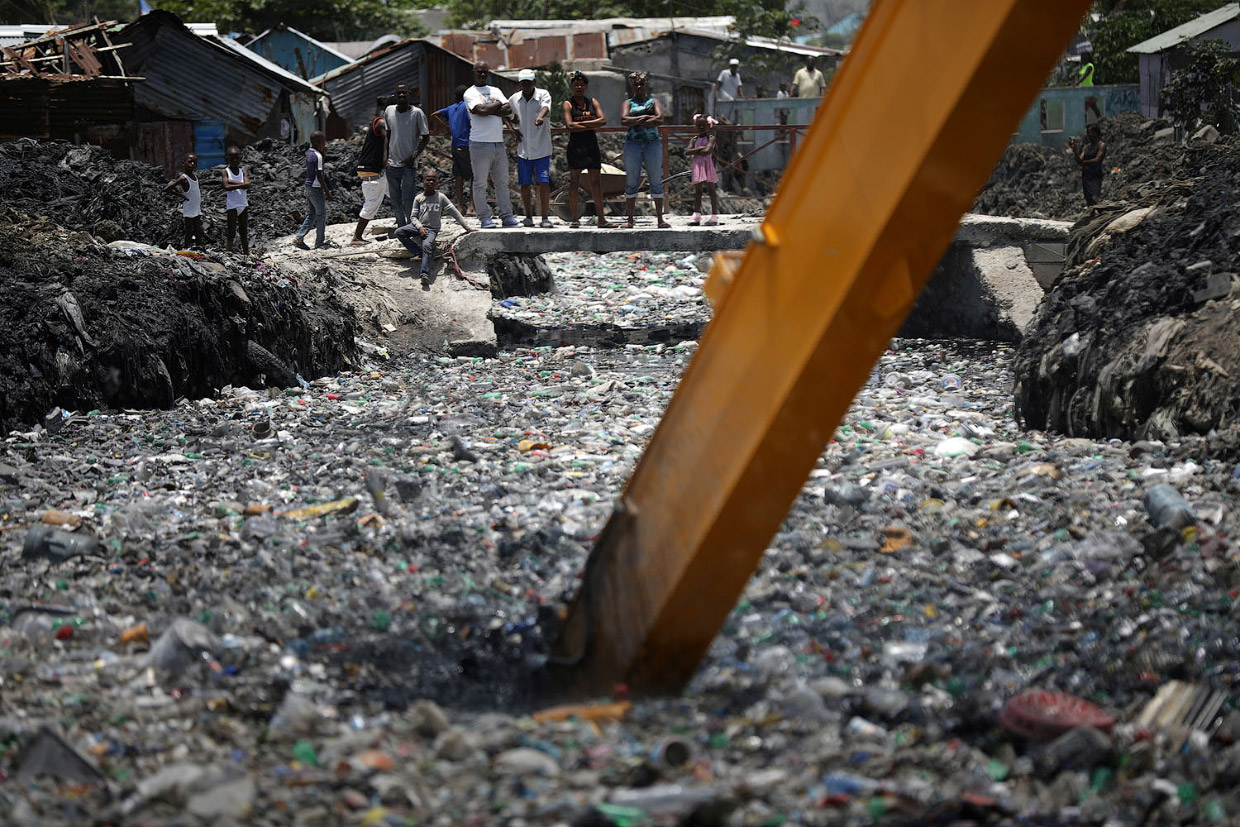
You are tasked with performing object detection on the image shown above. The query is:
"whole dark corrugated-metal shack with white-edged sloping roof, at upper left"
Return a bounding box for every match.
[118,10,324,145]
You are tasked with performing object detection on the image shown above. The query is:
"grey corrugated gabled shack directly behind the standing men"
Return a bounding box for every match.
[314,38,503,138]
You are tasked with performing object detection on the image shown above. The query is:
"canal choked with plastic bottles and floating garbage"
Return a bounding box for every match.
[0,254,1240,825]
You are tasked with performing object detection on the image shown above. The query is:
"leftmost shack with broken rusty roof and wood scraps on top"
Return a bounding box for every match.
[0,22,143,157]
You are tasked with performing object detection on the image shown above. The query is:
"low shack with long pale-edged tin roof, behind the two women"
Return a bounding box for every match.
[608,27,844,104]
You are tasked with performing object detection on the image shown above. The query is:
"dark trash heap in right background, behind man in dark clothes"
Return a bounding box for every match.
[972,112,1238,219]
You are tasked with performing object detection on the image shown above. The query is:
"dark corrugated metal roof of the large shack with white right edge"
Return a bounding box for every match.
[118,10,321,135]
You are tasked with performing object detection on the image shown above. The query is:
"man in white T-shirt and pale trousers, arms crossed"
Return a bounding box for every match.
[465,61,517,229]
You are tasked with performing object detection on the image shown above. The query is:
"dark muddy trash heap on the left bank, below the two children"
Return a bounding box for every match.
[0,208,356,430]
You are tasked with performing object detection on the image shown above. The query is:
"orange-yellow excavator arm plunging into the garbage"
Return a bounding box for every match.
[551,0,1090,696]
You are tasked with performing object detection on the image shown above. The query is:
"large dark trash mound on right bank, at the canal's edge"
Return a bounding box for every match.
[1016,137,1240,439]
